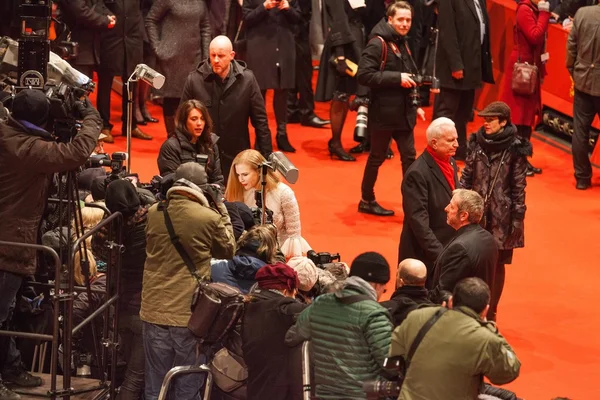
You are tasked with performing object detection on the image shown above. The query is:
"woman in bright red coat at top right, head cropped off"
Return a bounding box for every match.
[502,0,551,176]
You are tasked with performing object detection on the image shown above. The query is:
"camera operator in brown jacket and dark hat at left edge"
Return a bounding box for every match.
[0,89,102,398]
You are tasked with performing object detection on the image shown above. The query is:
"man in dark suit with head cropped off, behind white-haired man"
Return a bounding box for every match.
[433,0,494,160]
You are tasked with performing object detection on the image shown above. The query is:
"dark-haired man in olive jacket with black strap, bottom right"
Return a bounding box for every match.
[390,278,521,400]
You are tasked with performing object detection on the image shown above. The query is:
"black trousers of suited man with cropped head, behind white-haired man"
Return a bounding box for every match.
[433,88,475,159]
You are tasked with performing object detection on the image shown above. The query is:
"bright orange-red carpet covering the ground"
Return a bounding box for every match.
[98,88,600,400]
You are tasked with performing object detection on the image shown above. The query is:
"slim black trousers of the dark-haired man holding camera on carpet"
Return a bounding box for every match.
[361,129,417,201]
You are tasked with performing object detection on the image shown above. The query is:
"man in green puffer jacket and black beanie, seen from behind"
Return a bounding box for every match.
[286,252,392,400]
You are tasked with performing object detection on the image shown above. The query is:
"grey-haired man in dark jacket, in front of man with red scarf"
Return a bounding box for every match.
[430,189,498,314]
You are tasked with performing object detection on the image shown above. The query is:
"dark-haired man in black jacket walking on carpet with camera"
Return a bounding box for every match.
[357,1,425,216]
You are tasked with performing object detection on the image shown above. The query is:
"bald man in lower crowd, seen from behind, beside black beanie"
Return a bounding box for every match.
[381,258,433,327]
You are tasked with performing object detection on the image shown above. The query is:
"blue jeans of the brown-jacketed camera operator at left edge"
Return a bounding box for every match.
[0,271,23,380]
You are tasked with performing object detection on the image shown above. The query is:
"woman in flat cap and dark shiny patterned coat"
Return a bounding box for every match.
[460,101,531,320]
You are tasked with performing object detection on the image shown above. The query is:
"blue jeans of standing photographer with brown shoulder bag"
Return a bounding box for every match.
[143,322,205,400]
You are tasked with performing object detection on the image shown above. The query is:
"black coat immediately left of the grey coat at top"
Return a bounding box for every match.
[100,0,144,77]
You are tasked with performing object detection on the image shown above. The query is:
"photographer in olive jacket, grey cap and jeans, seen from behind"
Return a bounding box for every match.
[140,162,235,400]
